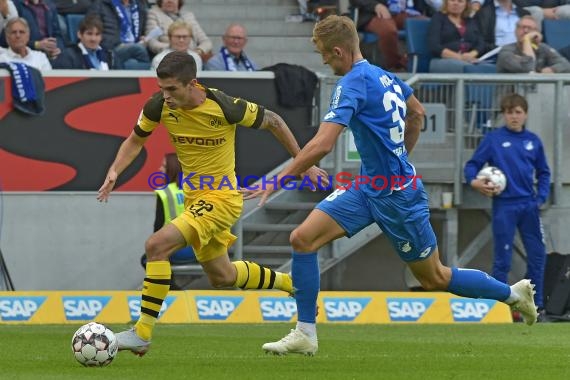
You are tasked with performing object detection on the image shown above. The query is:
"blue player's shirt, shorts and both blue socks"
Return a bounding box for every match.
[291,59,511,327]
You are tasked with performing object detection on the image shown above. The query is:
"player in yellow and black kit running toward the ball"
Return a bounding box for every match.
[97,52,328,356]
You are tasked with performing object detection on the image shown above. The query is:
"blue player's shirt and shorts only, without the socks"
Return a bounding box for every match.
[316,60,437,261]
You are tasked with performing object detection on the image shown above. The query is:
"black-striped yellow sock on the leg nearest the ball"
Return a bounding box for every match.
[135,261,172,340]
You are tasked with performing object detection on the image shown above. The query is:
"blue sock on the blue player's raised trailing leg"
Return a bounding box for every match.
[447,268,511,302]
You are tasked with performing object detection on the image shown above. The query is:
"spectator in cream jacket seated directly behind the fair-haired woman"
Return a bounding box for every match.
[146,0,212,61]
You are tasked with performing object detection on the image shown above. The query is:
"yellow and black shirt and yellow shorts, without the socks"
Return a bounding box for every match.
[135,87,264,262]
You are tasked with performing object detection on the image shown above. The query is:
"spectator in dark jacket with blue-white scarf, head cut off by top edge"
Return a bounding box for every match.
[88,0,150,70]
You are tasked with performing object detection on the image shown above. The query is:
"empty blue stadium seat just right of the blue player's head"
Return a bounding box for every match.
[405,18,431,74]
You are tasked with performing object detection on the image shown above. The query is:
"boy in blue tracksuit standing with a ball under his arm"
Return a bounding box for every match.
[464,94,550,309]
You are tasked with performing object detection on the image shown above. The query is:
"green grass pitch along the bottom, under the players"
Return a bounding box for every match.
[0,323,570,380]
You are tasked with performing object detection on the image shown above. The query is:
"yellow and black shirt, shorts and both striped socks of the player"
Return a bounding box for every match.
[131,86,293,340]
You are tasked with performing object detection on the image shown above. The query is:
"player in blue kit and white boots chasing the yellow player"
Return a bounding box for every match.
[245,16,537,355]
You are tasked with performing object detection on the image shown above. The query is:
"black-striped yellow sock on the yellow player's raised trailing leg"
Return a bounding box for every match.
[232,261,293,293]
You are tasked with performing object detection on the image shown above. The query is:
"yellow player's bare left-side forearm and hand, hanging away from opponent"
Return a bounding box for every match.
[97,131,146,202]
